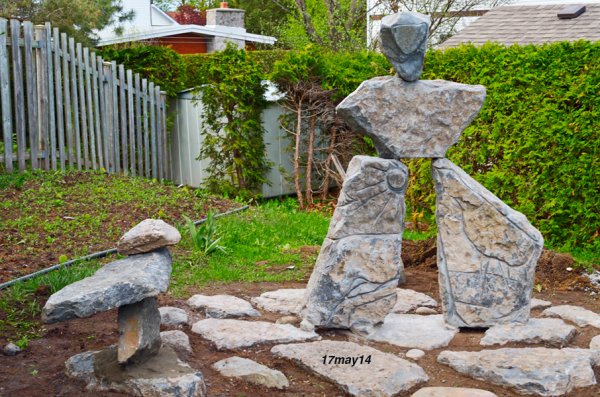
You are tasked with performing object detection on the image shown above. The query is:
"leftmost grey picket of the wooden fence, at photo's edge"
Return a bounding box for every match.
[0,18,13,172]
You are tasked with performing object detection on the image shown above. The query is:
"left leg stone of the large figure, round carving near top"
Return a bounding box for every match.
[301,156,408,333]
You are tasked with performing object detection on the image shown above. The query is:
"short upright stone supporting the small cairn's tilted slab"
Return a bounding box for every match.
[117,297,161,364]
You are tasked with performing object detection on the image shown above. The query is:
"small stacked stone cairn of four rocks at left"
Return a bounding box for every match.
[42,219,206,397]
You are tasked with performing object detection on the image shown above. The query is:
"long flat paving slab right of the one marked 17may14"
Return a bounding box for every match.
[438,347,600,396]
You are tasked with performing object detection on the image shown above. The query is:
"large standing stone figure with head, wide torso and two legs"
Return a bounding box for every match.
[301,12,543,333]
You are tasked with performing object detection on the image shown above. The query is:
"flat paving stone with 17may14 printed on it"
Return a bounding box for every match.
[271,340,428,397]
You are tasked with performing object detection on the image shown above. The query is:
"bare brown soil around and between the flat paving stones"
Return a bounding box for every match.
[0,240,600,397]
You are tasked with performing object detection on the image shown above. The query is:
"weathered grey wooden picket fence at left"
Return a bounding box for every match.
[0,18,170,179]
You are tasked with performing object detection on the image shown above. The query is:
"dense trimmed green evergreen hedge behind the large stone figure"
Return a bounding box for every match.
[101,41,600,252]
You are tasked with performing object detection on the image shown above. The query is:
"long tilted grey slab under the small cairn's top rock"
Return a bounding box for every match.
[42,248,171,323]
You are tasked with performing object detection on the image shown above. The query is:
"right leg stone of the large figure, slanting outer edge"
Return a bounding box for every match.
[432,159,544,327]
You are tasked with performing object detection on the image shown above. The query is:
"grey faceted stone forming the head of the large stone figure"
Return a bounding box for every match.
[379,12,431,81]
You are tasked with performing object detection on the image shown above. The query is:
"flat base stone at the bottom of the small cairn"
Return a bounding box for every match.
[65,346,207,397]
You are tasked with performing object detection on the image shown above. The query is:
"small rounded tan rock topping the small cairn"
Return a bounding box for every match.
[117,219,181,255]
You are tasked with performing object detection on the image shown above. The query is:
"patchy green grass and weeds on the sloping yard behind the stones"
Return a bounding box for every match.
[0,172,598,346]
